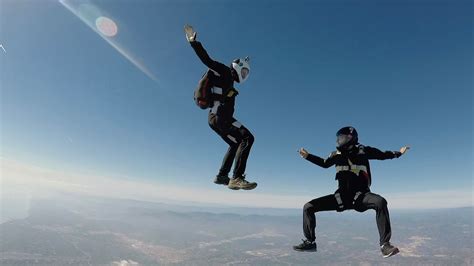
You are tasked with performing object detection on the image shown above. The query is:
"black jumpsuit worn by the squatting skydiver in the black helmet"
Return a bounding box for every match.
[303,145,401,245]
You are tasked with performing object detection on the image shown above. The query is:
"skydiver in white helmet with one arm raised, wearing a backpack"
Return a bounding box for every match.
[184,25,257,190]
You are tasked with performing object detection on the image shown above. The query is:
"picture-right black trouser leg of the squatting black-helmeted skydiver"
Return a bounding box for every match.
[362,192,392,246]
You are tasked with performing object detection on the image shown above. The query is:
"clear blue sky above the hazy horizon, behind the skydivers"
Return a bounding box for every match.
[0,0,473,208]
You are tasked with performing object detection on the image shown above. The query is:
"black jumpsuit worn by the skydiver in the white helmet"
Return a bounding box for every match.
[190,41,254,177]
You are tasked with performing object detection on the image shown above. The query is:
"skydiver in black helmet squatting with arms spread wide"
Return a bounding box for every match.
[293,127,409,257]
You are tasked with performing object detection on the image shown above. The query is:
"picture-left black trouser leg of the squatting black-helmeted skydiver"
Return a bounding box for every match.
[303,194,338,242]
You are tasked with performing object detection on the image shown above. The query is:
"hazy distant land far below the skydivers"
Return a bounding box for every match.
[0,195,474,265]
